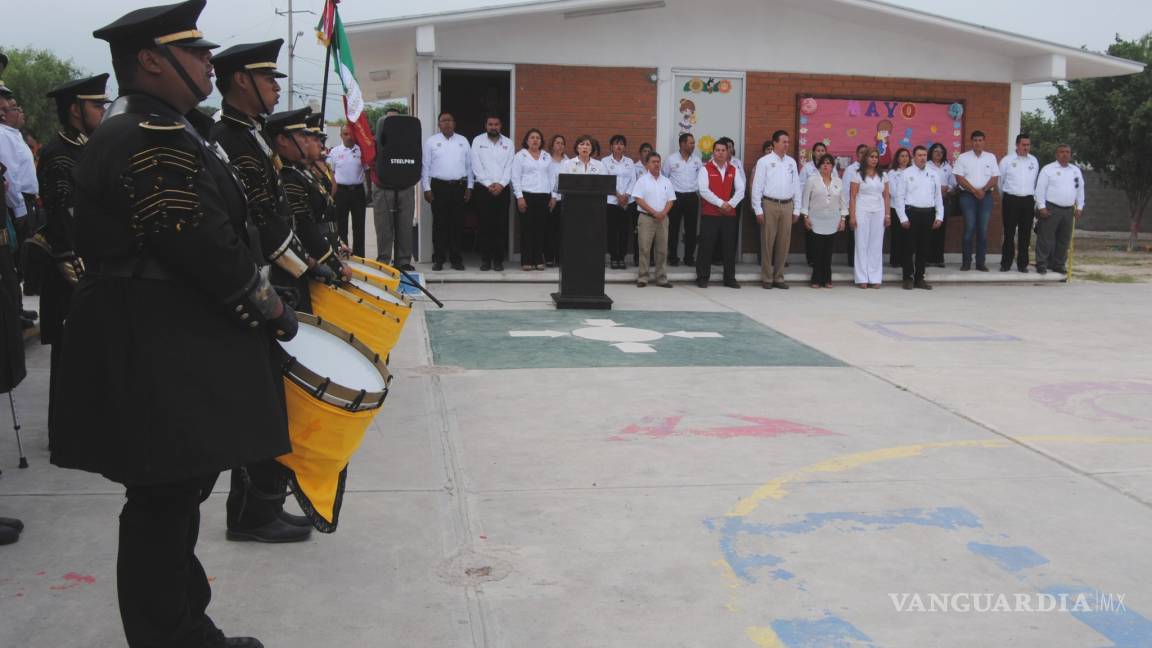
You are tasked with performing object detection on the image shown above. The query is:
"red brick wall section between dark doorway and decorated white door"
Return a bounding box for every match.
[509,65,655,157]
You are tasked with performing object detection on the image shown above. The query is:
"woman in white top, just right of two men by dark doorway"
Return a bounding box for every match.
[511,128,556,270]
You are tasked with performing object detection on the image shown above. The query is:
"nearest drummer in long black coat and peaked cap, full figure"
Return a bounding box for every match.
[52,0,297,648]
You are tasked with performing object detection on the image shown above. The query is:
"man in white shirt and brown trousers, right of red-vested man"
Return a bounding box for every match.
[752,130,801,289]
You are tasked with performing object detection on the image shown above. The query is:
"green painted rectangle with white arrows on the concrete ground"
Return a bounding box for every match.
[426,310,844,369]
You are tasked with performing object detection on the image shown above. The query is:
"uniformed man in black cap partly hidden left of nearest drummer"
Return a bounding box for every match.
[36,74,108,446]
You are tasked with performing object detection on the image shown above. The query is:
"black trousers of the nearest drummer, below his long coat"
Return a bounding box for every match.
[116,474,219,648]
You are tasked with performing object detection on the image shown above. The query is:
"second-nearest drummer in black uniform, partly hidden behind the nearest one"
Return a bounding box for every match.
[212,38,311,542]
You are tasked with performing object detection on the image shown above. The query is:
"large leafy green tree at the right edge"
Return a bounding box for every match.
[1048,33,1152,250]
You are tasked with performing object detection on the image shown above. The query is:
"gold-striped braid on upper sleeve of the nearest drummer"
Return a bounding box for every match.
[124,133,203,236]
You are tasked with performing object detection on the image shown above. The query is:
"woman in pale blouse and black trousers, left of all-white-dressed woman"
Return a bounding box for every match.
[801,153,848,288]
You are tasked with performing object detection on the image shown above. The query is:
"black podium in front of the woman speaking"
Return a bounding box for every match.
[552,173,616,310]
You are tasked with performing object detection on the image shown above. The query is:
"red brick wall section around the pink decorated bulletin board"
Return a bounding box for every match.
[742,71,1009,252]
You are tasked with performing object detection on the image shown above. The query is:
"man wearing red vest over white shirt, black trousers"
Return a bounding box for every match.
[696,137,744,288]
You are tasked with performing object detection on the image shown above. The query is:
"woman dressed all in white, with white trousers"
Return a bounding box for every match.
[848,149,892,288]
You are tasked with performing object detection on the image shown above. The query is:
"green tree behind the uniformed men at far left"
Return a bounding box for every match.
[0,46,84,142]
